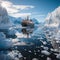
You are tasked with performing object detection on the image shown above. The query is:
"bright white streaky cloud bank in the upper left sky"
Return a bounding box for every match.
[1,0,34,17]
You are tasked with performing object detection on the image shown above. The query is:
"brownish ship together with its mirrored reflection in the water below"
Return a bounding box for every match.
[21,16,34,38]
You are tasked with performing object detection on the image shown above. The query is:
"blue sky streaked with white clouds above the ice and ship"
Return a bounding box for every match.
[0,0,60,22]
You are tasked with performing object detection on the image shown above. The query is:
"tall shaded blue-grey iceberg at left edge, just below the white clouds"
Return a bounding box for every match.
[0,4,12,29]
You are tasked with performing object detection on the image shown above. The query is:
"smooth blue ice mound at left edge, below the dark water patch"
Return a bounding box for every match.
[0,32,13,49]
